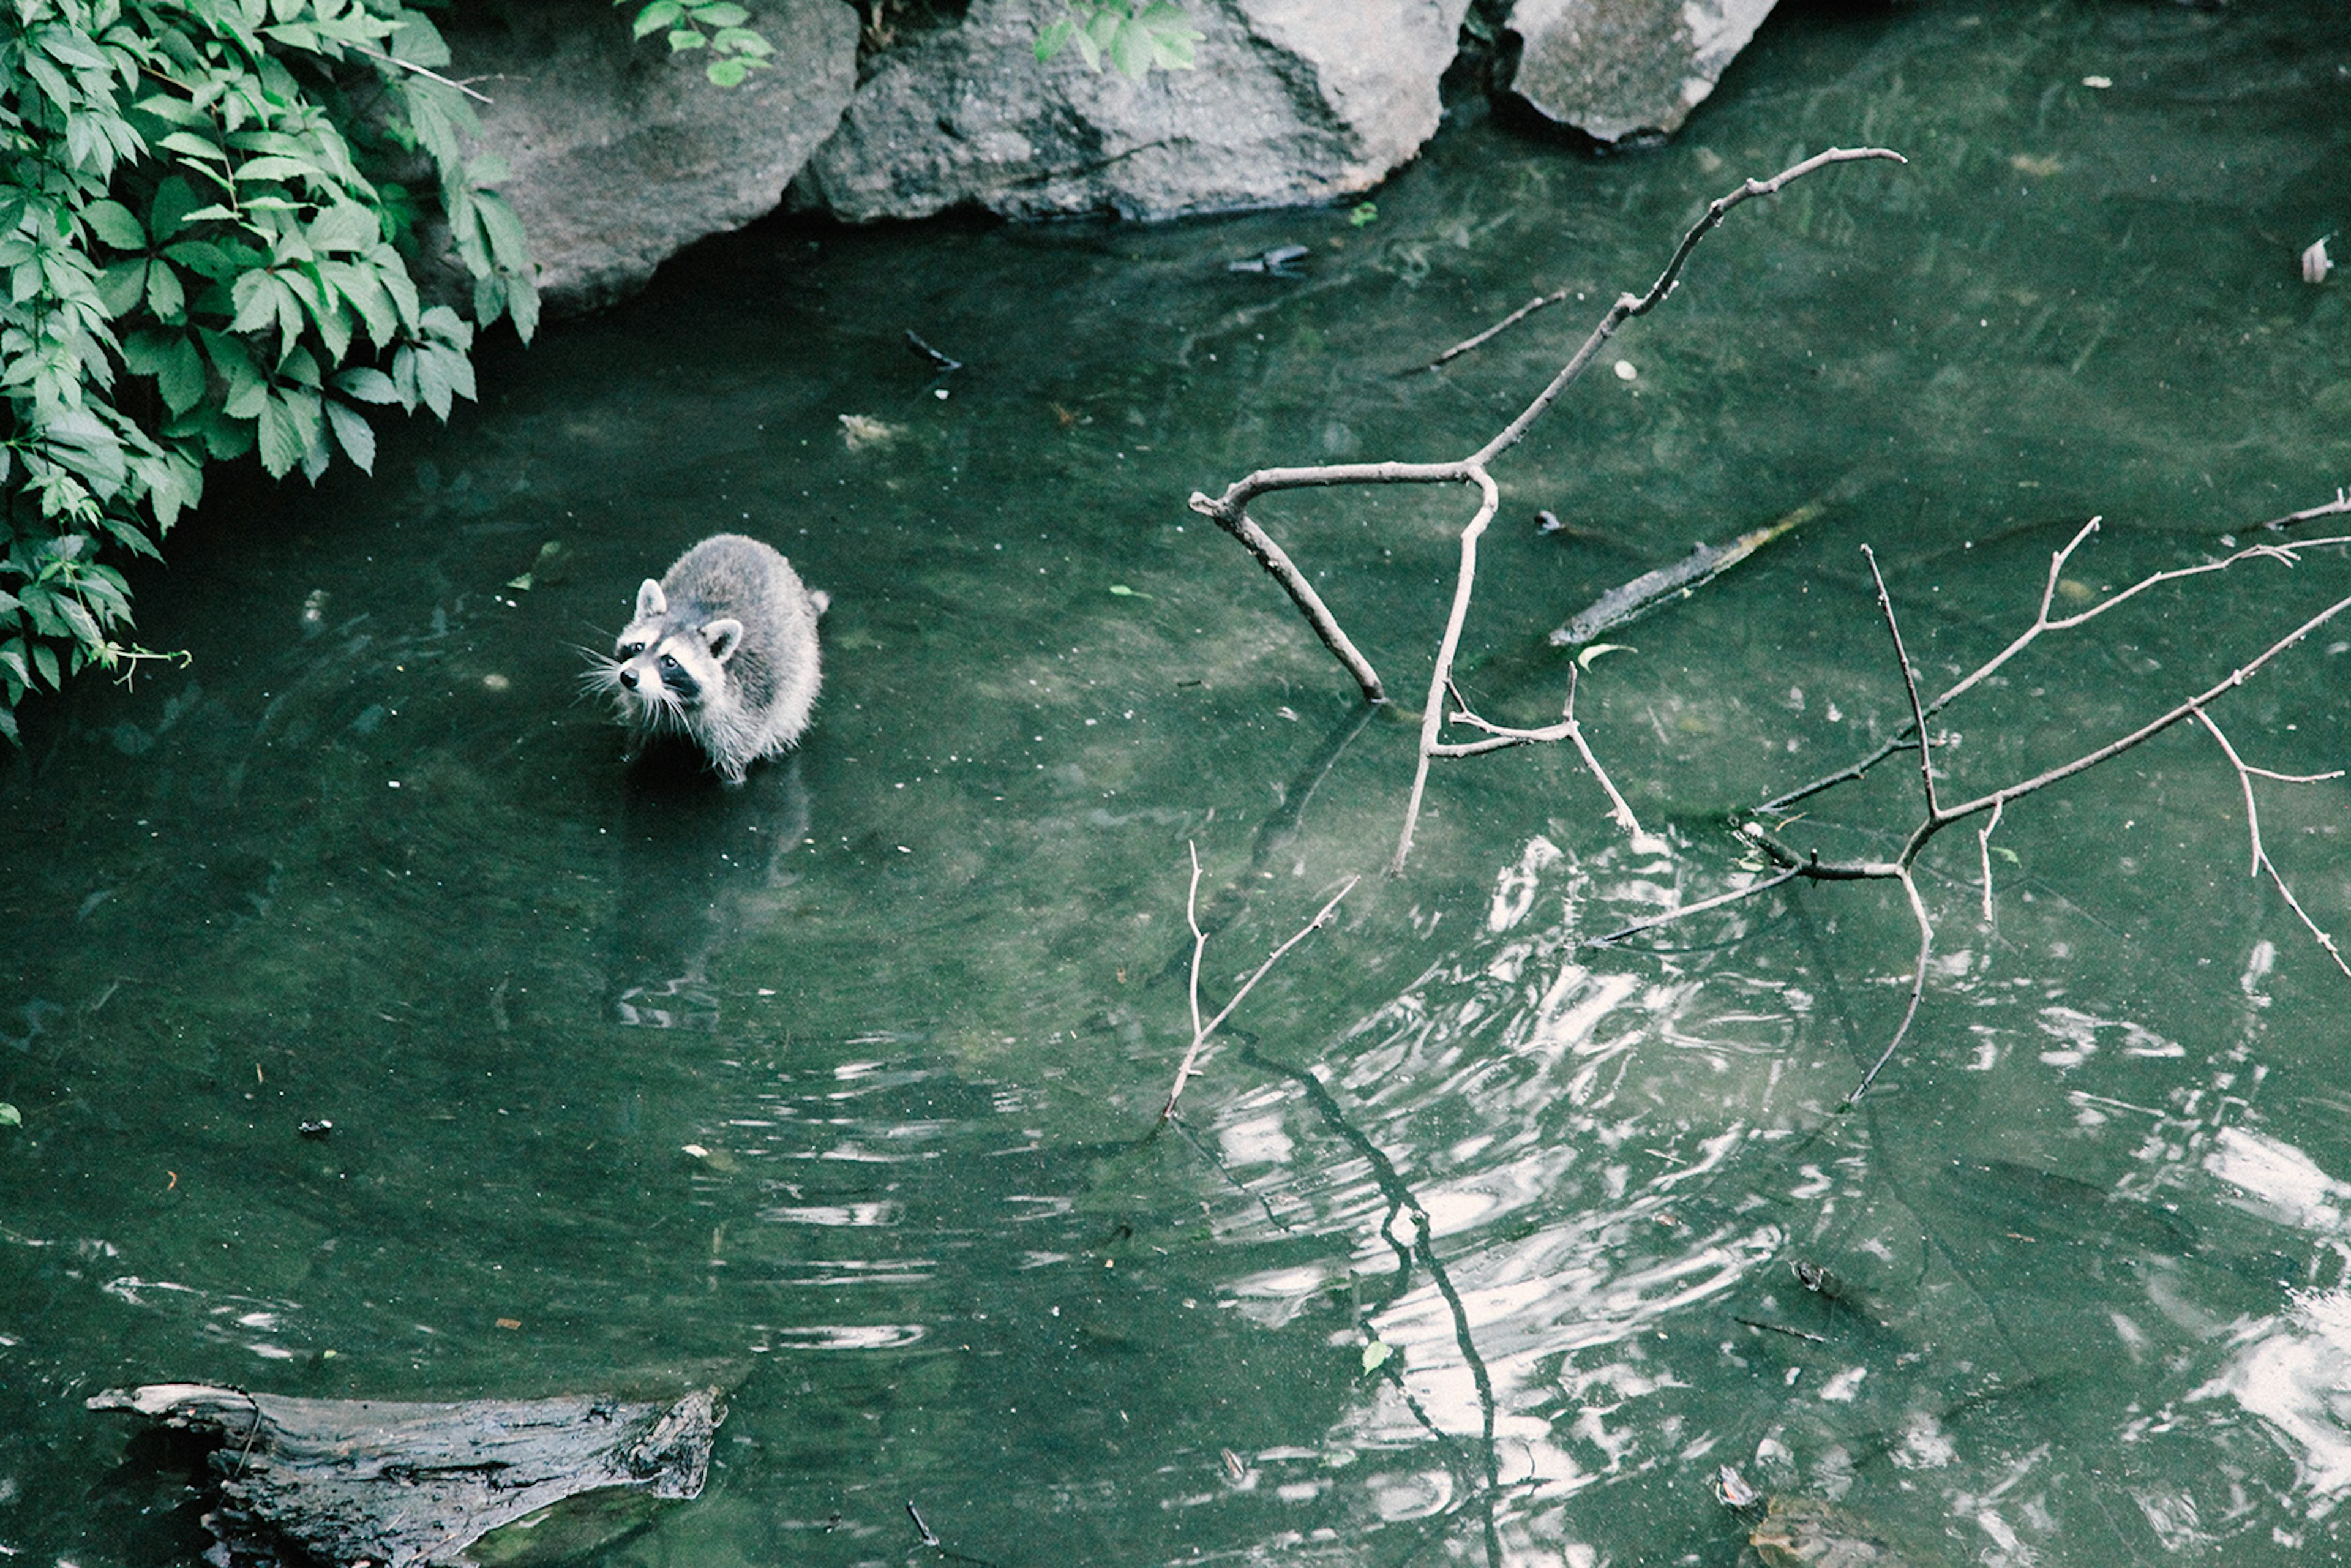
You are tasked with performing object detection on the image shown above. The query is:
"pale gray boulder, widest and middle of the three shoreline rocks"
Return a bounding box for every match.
[792,0,1469,221]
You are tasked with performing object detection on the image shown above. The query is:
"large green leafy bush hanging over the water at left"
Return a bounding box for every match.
[0,0,538,740]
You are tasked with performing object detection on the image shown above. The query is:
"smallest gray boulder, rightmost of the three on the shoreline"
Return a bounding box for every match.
[1507,0,1772,141]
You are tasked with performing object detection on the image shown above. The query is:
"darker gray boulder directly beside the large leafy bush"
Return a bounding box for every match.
[447,0,858,313]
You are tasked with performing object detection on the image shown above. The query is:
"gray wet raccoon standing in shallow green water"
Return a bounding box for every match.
[588,534,832,785]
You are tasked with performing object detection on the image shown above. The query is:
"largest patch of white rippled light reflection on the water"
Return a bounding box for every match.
[1218,837,1787,1523]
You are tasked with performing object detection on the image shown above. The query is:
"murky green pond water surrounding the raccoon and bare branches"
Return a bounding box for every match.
[0,0,2351,1568]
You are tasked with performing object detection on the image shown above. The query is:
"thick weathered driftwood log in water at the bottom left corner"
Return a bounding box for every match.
[87,1382,724,1568]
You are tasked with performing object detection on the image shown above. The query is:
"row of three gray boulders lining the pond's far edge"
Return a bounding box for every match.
[449,0,1772,313]
